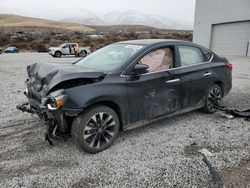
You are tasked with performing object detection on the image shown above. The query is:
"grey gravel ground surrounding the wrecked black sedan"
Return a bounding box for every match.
[0,53,250,188]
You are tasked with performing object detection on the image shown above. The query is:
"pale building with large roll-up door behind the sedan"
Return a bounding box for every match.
[193,0,250,56]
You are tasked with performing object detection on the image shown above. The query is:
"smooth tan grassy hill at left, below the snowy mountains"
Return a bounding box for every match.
[0,14,94,32]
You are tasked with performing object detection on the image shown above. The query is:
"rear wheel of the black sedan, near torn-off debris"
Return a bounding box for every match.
[202,84,223,114]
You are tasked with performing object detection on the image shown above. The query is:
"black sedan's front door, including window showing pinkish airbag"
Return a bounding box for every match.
[127,46,180,123]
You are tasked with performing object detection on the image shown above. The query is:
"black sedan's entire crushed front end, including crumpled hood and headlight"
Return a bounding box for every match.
[16,63,103,144]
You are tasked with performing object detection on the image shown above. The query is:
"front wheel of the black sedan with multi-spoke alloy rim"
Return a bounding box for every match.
[71,105,120,153]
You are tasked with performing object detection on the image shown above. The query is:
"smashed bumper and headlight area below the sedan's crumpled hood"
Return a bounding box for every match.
[17,83,78,145]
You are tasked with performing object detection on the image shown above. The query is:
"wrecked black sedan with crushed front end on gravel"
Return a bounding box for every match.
[17,39,232,153]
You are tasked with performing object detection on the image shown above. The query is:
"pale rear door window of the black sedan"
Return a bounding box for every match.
[179,46,203,66]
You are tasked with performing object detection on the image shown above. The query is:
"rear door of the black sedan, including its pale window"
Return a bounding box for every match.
[177,45,213,108]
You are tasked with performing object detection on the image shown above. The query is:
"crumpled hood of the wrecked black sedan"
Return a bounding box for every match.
[27,63,104,94]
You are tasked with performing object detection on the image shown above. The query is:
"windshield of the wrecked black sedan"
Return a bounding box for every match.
[76,44,144,71]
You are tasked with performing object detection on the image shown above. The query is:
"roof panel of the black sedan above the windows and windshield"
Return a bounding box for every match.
[118,39,191,46]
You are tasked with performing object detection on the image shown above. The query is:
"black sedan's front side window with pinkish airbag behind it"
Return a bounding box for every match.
[138,47,173,72]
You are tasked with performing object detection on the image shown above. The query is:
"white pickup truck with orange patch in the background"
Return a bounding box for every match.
[49,43,91,57]
